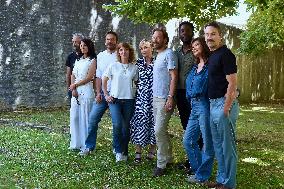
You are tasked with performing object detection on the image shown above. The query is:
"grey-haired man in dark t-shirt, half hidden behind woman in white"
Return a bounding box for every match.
[65,33,83,101]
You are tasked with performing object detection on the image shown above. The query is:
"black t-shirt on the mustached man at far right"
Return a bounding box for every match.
[208,45,237,99]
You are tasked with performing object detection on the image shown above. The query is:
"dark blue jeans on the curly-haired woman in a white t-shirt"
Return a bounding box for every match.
[109,99,135,156]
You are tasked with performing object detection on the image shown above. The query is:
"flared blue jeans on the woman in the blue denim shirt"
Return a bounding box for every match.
[183,98,214,182]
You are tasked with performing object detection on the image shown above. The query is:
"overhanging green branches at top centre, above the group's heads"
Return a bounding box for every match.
[104,0,239,26]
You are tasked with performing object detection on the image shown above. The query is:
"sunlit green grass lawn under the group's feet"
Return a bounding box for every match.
[0,105,284,189]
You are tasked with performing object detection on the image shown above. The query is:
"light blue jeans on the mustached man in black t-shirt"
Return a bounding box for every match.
[210,97,239,188]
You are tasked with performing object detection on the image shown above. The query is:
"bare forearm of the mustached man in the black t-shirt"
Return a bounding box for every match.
[224,73,237,116]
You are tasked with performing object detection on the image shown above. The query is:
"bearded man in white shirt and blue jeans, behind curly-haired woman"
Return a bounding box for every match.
[79,31,118,155]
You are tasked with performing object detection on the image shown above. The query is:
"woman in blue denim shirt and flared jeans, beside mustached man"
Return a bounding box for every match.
[183,37,214,183]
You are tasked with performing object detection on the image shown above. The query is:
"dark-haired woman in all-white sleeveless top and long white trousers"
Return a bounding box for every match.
[69,39,97,150]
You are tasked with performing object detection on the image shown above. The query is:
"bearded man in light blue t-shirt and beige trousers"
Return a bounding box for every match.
[152,28,178,177]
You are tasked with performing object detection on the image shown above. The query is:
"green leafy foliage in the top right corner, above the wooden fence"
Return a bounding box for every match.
[239,0,284,55]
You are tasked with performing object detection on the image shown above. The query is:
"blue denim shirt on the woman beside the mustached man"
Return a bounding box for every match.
[186,64,208,98]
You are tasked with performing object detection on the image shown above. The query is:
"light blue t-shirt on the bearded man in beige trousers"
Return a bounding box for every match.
[153,48,177,98]
